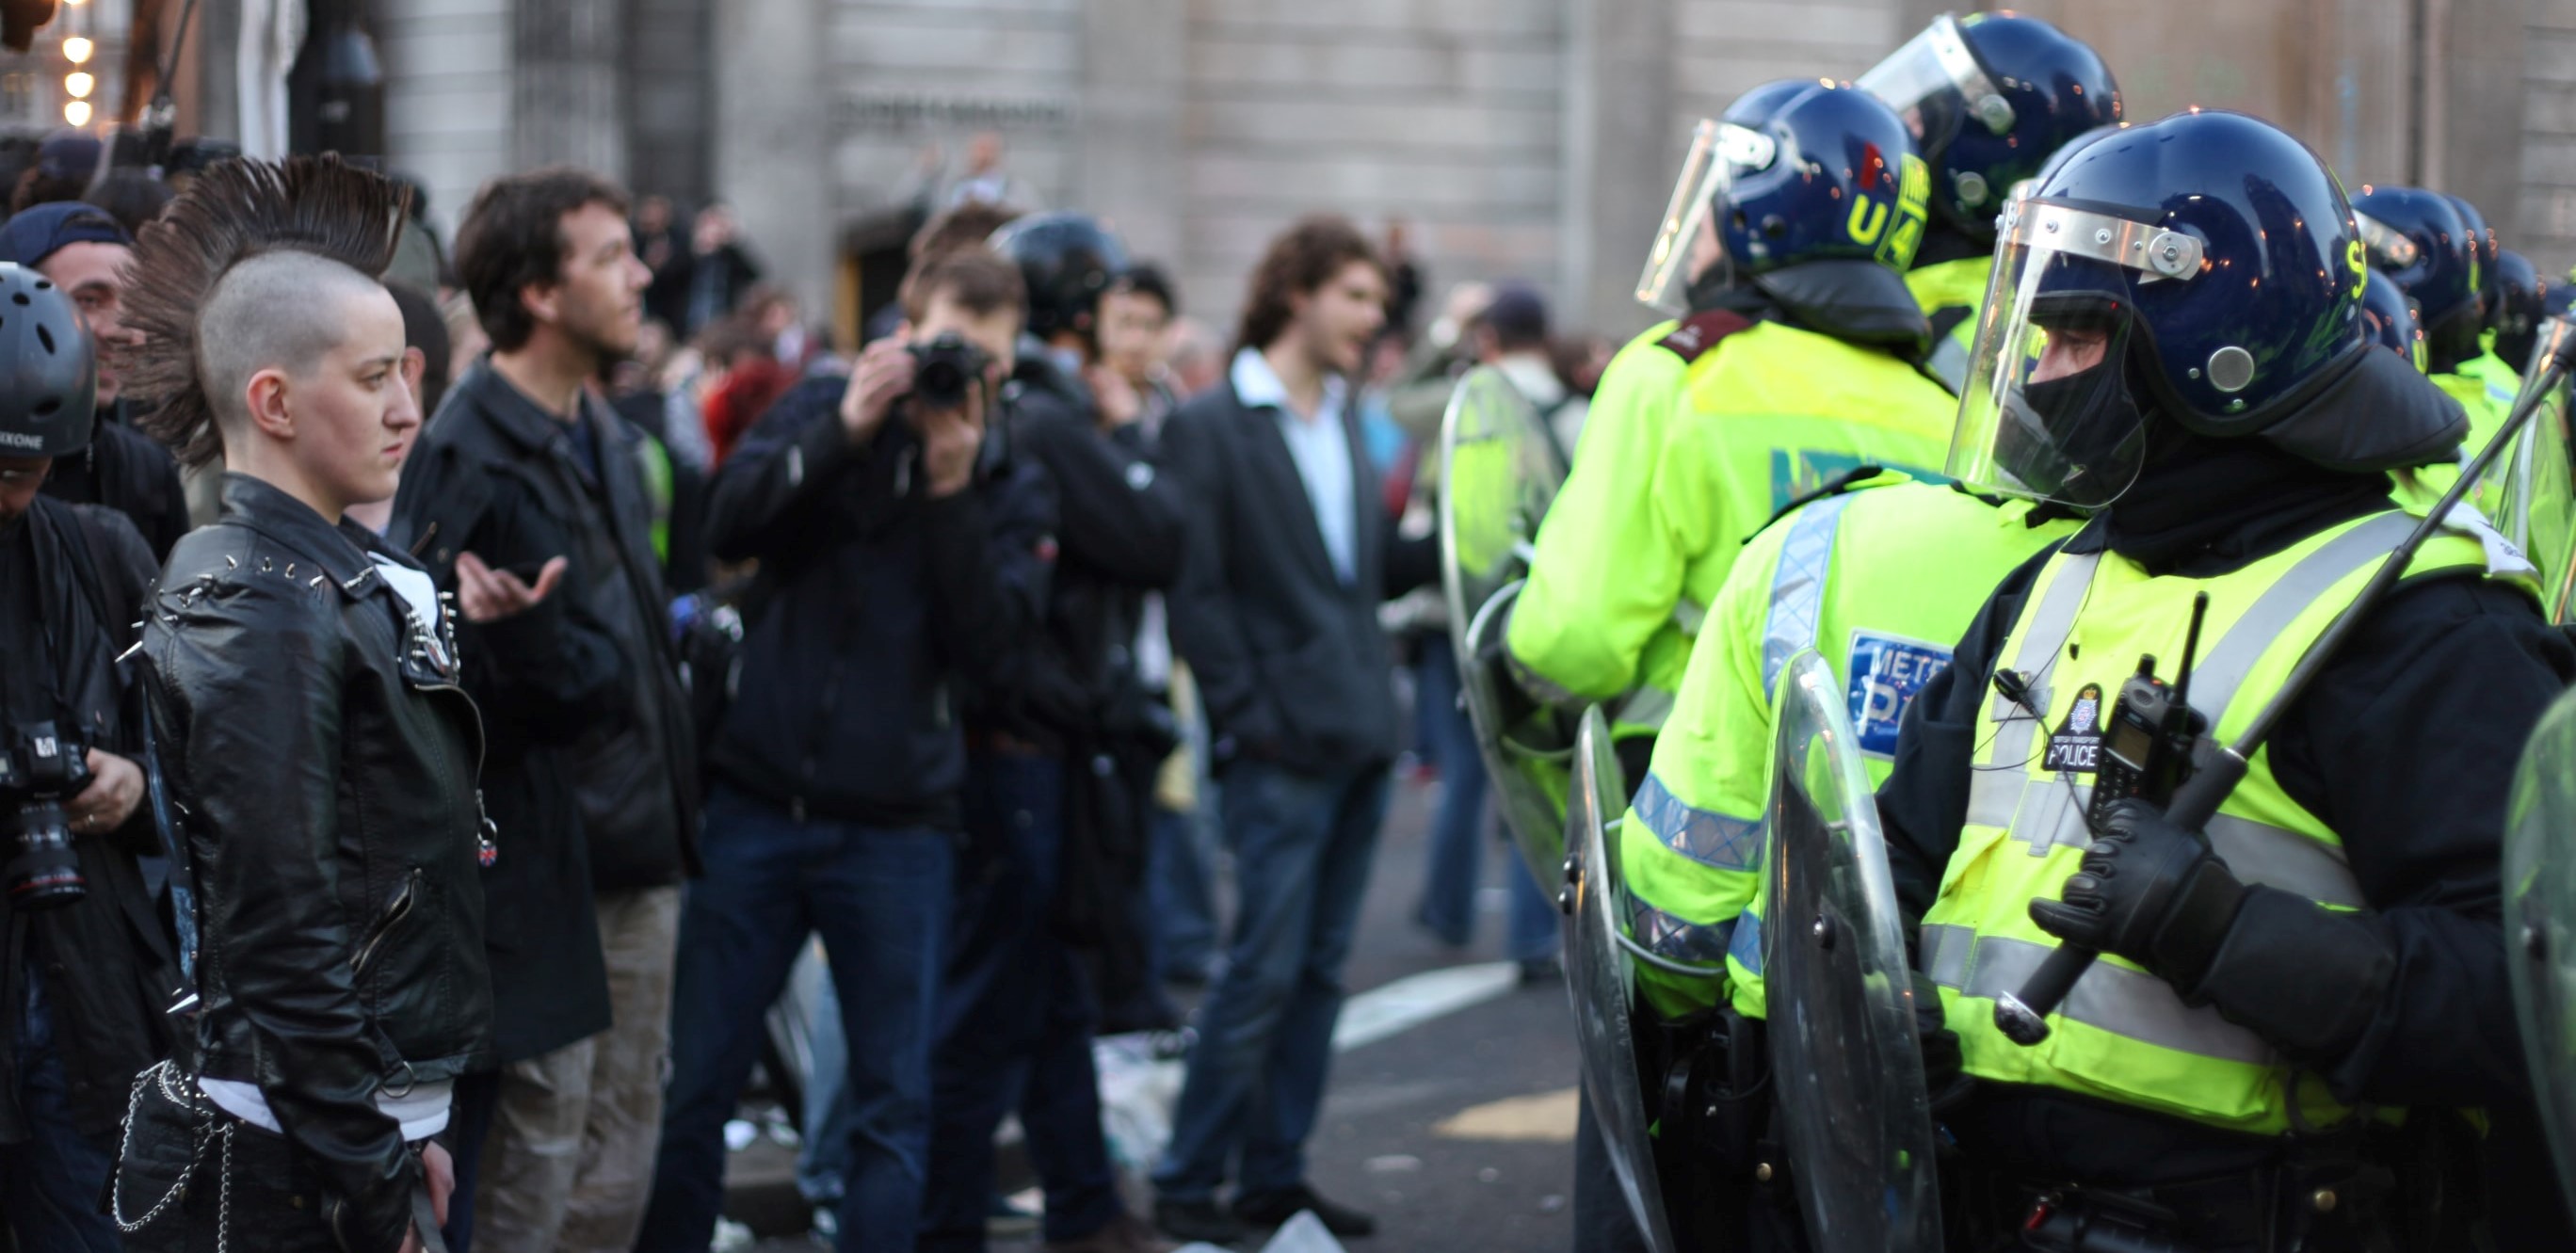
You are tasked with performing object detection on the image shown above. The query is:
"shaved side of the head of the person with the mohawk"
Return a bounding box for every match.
[196,250,394,436]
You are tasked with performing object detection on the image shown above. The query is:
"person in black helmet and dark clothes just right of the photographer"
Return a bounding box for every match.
[920,214,1183,1253]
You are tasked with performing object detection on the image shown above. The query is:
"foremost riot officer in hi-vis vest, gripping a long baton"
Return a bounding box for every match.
[1880,111,2576,1250]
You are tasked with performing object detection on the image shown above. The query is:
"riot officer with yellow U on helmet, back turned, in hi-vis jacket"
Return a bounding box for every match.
[1507,80,1950,776]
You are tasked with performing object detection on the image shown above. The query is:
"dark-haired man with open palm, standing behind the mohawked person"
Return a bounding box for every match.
[392,168,698,1253]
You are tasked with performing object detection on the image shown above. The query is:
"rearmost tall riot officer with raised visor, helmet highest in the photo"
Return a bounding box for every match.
[1858,13,2120,392]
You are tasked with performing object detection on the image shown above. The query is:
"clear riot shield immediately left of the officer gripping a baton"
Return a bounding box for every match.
[1762,650,1940,1253]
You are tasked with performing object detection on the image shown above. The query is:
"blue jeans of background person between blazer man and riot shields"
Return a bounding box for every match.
[1414,635,1561,962]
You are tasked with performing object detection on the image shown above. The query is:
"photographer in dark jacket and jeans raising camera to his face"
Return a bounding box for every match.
[636,250,1043,1253]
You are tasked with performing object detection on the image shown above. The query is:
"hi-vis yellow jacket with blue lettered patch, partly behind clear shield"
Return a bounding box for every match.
[1618,474,2076,1019]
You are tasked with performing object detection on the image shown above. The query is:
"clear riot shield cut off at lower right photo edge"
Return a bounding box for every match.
[2504,694,2576,1204]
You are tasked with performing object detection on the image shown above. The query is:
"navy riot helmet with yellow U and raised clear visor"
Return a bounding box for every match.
[1638,80,1932,312]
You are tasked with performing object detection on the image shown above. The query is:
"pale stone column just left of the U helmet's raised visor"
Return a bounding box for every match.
[1558,0,1680,338]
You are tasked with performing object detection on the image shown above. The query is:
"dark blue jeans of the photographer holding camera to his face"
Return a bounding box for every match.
[636,784,956,1253]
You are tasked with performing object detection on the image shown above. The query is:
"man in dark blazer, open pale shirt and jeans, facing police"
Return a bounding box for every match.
[1154,219,1432,1243]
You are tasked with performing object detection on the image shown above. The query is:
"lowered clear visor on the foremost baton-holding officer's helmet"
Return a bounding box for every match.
[1947,201,2205,508]
